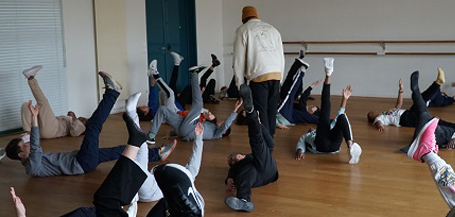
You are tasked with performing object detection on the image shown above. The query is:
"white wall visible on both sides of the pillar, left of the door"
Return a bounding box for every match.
[63,0,148,117]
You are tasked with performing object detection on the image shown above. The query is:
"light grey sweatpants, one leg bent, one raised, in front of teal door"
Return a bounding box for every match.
[150,73,203,140]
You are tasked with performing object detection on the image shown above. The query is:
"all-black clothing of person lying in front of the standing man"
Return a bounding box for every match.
[235,116,278,201]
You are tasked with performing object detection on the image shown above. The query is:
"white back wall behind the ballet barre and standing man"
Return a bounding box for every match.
[222,0,455,97]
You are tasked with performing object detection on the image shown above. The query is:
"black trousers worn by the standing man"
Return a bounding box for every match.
[250,80,280,137]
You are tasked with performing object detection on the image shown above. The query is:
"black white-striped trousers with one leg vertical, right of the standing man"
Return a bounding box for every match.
[314,84,352,152]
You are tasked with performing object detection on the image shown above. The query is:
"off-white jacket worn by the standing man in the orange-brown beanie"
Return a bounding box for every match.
[233,19,284,88]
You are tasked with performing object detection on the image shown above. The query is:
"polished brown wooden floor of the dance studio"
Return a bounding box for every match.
[0,97,455,217]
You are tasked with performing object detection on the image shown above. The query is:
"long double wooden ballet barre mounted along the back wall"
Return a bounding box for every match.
[283,40,455,56]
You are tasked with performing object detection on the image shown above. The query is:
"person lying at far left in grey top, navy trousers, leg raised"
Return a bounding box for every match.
[5,71,173,177]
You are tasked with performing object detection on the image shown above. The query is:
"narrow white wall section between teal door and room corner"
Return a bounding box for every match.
[196,0,225,91]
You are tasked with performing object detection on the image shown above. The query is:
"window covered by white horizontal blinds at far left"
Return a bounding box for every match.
[0,0,68,133]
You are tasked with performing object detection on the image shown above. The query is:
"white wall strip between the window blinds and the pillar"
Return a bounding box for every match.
[62,0,98,117]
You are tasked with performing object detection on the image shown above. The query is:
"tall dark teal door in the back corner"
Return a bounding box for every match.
[146,0,197,92]
